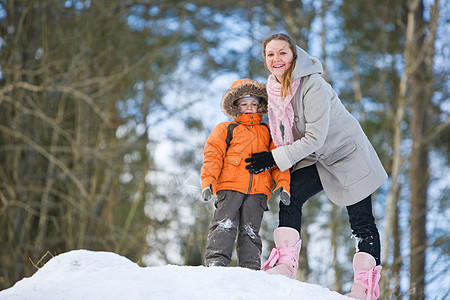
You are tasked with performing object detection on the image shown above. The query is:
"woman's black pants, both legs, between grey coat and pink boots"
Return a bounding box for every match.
[279,165,380,265]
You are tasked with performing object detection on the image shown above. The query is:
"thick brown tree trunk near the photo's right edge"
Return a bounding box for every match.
[409,1,438,300]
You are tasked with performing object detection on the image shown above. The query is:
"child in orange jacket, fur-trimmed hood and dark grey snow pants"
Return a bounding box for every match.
[201,78,290,270]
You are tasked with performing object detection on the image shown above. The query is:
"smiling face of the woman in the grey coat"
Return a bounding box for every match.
[264,40,294,81]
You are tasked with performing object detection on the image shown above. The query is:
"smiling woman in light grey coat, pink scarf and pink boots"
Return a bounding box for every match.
[246,33,387,299]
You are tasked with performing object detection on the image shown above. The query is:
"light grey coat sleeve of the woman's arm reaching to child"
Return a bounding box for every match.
[272,75,332,170]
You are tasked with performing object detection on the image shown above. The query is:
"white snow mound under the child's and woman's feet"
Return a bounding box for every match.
[0,250,350,300]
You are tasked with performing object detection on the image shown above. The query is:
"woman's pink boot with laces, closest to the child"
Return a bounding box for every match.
[262,227,302,278]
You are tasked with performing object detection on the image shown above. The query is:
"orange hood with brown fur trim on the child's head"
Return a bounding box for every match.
[222,78,267,118]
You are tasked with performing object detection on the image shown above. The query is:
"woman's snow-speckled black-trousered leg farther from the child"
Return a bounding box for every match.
[347,195,381,265]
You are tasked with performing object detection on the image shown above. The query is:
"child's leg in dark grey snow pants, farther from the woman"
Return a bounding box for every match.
[205,191,244,267]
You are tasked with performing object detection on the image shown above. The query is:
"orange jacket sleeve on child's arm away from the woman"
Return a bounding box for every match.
[200,123,227,194]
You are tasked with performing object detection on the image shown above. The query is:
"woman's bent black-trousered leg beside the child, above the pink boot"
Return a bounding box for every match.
[278,164,323,233]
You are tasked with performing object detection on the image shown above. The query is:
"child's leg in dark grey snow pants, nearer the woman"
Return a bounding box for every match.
[236,194,267,270]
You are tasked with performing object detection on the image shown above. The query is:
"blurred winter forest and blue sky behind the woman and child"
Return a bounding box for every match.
[0,0,450,299]
